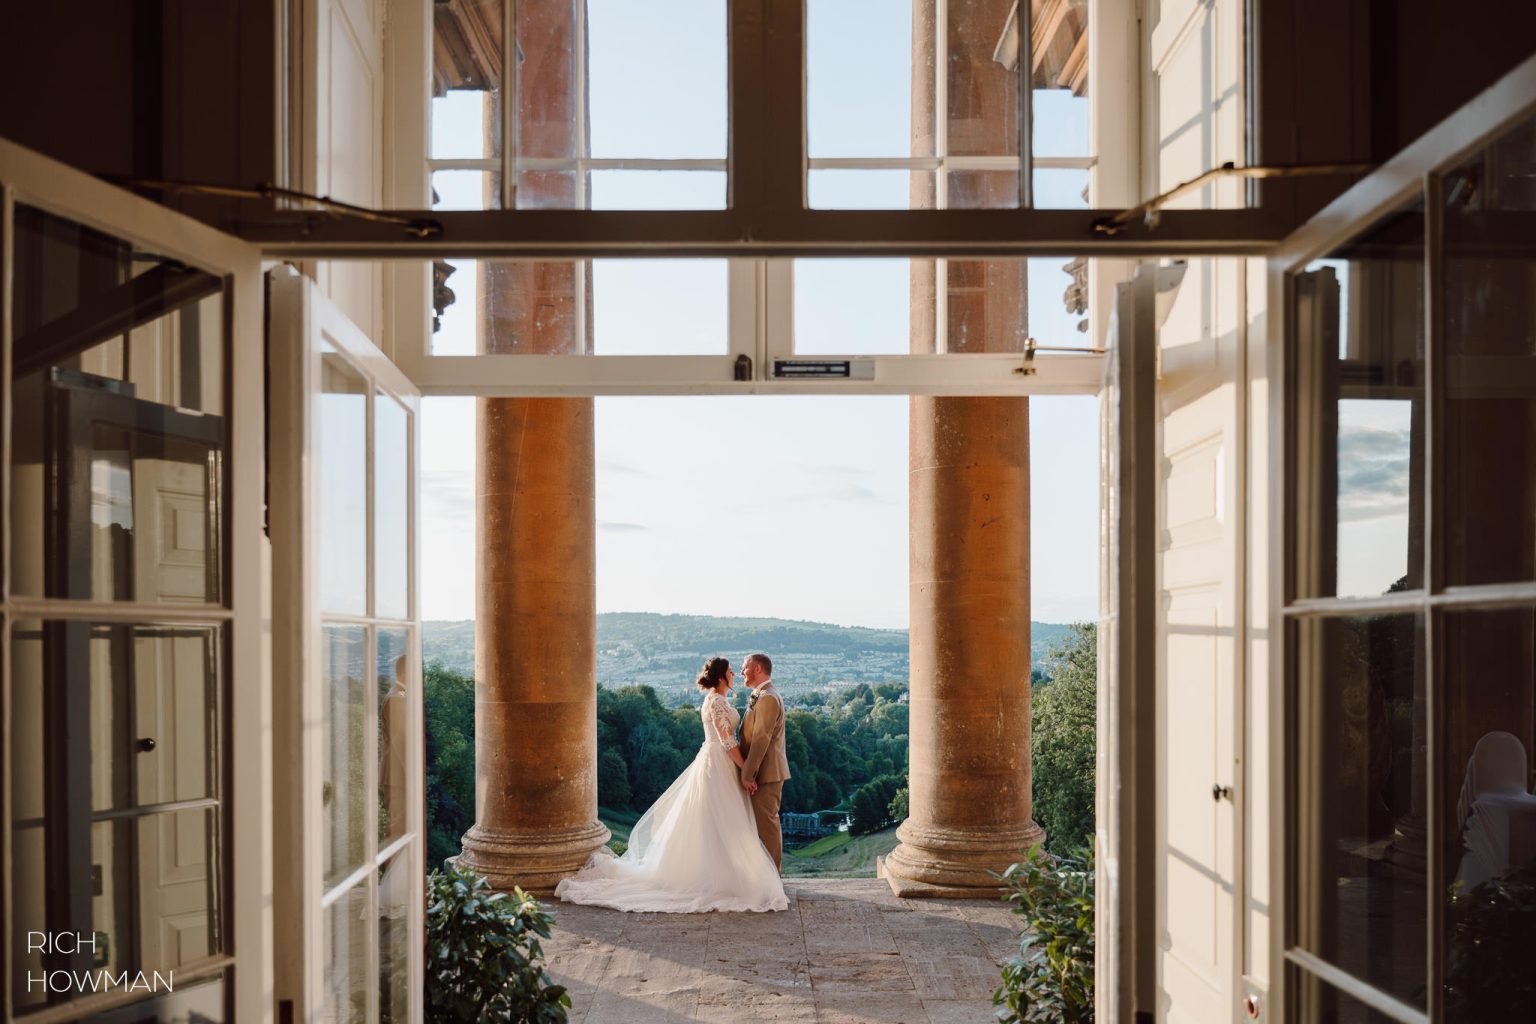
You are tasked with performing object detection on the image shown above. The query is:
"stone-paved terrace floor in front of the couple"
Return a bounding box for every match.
[545,878,1018,1024]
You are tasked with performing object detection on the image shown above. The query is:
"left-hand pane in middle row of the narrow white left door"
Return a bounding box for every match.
[321,626,373,887]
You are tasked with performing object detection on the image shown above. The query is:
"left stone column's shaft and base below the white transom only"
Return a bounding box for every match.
[459,398,608,890]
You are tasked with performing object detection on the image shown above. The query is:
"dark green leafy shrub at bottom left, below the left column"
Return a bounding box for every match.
[425,867,571,1024]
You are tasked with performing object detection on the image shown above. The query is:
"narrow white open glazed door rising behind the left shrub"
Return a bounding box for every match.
[270,270,424,1022]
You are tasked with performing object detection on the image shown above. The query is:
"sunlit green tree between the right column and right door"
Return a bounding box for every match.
[1031,622,1098,852]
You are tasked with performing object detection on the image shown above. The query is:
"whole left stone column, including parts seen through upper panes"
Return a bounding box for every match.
[459,5,608,892]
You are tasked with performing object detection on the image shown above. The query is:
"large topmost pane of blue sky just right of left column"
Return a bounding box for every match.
[589,0,728,158]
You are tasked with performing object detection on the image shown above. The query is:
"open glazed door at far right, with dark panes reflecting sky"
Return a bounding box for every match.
[1270,58,1536,1024]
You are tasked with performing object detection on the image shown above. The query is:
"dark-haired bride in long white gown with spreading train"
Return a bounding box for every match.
[554,657,790,913]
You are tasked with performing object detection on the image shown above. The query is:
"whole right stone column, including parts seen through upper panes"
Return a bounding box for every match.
[882,0,1044,895]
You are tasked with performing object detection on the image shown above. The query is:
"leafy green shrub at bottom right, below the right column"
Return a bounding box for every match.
[992,846,1094,1024]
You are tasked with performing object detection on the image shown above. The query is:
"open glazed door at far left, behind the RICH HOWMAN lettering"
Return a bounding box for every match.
[0,141,272,1021]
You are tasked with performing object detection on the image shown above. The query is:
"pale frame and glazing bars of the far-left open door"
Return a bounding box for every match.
[0,138,273,1024]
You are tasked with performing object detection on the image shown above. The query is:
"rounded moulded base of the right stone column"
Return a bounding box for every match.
[879,821,1046,898]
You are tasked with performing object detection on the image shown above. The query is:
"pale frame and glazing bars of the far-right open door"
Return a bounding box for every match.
[1267,57,1536,1024]
